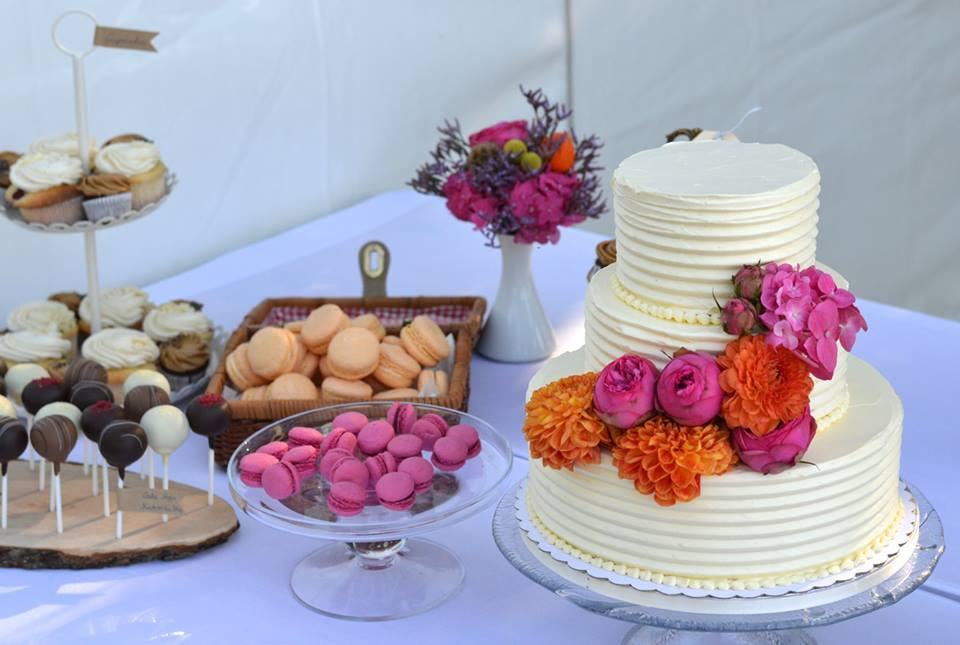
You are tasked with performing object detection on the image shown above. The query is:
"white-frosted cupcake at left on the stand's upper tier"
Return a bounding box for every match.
[4,152,83,224]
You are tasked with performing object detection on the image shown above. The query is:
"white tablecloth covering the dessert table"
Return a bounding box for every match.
[0,191,960,645]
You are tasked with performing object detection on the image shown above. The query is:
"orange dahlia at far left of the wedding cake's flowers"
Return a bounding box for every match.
[523,372,610,469]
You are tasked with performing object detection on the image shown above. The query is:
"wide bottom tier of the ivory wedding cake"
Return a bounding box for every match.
[527,351,903,588]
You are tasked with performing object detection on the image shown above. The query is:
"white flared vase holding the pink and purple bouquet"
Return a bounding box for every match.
[477,235,557,363]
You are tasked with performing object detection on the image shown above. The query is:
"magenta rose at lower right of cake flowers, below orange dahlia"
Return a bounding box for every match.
[731,407,817,475]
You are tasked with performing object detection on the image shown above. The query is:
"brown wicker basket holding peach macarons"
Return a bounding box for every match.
[207,296,487,466]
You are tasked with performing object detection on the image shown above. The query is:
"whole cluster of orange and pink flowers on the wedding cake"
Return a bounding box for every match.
[523,263,867,506]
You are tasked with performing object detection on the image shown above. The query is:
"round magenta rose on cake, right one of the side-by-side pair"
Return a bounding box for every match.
[657,352,723,426]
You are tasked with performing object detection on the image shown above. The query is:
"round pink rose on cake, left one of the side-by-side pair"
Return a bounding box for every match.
[593,354,657,429]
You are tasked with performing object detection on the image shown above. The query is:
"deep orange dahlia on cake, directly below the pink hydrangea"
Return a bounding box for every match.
[717,336,813,437]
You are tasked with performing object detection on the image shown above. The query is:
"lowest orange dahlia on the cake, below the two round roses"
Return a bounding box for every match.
[613,416,737,506]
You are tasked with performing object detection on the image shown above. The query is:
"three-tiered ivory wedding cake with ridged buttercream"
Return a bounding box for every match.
[525,142,903,588]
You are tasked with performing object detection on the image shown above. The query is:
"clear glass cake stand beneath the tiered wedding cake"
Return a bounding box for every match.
[493,482,944,645]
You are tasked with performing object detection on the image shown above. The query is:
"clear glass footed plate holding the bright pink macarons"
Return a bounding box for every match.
[227,401,513,620]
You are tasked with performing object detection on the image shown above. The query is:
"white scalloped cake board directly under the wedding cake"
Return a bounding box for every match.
[514,481,920,614]
